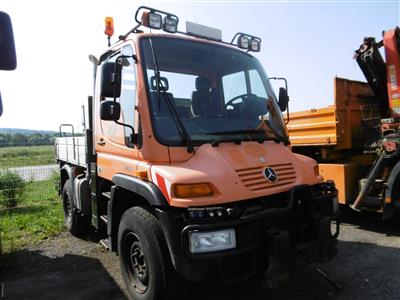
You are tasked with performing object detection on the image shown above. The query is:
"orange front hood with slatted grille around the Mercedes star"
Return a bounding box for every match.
[151,141,322,207]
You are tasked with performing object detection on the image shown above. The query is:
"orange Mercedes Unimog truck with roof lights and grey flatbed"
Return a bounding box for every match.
[56,7,338,299]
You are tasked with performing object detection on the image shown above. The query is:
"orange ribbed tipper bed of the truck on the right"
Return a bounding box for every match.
[287,77,373,150]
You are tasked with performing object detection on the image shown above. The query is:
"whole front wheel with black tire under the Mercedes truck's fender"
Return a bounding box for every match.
[118,207,173,300]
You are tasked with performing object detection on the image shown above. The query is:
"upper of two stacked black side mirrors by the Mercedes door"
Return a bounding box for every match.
[100,62,121,98]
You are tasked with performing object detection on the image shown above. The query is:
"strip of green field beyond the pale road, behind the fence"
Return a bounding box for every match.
[0,145,55,168]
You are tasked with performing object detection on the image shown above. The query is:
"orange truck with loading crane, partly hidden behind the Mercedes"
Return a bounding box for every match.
[287,27,400,219]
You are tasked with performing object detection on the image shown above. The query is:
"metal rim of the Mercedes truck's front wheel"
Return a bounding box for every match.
[123,232,149,294]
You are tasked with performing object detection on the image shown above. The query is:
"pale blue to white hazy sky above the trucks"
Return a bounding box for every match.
[0,0,400,130]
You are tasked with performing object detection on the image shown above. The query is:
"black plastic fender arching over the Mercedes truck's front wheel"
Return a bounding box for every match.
[112,174,169,207]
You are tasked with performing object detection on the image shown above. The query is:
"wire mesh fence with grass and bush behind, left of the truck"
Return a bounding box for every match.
[0,129,63,254]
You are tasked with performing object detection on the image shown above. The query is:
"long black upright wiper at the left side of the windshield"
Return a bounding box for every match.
[150,38,194,153]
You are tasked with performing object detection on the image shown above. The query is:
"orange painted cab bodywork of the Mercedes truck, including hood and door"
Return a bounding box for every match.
[94,34,322,207]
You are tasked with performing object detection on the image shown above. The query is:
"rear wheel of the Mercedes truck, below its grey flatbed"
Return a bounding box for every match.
[62,179,90,237]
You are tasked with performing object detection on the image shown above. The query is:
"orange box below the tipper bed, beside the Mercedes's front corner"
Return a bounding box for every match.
[318,163,360,204]
